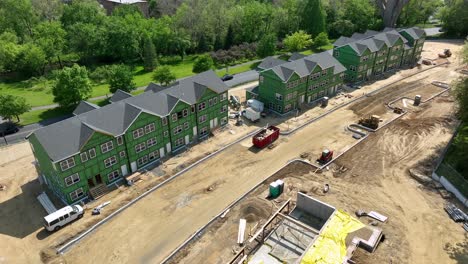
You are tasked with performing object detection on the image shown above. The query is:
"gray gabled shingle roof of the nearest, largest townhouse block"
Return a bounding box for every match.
[29,71,229,162]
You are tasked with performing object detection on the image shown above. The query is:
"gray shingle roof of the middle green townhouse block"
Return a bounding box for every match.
[271,51,346,81]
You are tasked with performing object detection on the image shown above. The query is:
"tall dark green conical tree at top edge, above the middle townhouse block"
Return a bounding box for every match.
[301,0,326,35]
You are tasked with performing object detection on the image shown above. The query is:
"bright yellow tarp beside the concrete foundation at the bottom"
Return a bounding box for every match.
[301,210,365,264]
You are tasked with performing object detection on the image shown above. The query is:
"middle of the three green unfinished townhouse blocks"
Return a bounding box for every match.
[246,52,346,114]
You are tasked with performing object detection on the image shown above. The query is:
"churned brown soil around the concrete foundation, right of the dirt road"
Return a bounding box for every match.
[171,81,468,264]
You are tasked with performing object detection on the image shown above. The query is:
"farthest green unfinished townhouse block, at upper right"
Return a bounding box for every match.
[333,27,425,82]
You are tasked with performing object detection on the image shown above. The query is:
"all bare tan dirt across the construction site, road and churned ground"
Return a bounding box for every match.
[0,39,463,263]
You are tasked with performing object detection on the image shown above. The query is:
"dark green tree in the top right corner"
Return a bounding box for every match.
[440,0,468,37]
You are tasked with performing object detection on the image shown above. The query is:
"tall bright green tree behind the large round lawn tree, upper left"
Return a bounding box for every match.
[34,21,66,67]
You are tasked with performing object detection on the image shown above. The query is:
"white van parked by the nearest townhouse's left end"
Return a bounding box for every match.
[44,205,84,231]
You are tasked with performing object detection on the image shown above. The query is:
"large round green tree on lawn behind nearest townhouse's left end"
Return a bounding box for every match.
[52,64,92,108]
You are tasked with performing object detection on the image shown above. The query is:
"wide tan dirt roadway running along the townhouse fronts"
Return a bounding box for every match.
[0,39,461,263]
